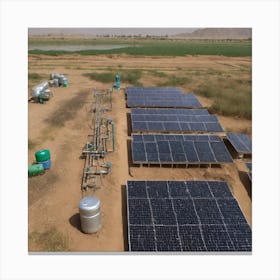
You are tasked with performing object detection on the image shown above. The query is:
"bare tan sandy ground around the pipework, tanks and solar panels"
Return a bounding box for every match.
[28,55,252,252]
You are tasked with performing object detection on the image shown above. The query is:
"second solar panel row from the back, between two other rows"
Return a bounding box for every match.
[131,108,223,132]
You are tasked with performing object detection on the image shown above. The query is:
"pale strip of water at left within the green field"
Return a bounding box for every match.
[28,45,128,52]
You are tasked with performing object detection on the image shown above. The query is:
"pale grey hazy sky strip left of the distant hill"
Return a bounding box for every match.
[28,28,198,36]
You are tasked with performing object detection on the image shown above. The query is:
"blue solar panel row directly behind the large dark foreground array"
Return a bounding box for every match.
[131,134,232,164]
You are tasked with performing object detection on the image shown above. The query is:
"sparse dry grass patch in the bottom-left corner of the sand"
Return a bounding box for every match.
[28,228,69,252]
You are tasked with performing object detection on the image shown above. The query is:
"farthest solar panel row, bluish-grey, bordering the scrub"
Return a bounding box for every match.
[126,88,202,108]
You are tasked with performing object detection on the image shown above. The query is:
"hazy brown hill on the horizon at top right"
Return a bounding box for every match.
[176,28,252,39]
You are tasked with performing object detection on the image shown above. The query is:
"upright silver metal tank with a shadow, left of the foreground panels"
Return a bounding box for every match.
[79,196,101,233]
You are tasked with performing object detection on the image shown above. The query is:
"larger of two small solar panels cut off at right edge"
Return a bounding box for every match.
[227,132,252,154]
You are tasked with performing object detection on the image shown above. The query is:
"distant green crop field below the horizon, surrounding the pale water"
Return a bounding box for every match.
[29,40,252,56]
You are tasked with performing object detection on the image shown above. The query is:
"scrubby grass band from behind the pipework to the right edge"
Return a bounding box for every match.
[83,68,252,119]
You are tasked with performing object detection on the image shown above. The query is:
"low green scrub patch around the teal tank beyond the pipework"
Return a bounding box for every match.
[83,69,142,86]
